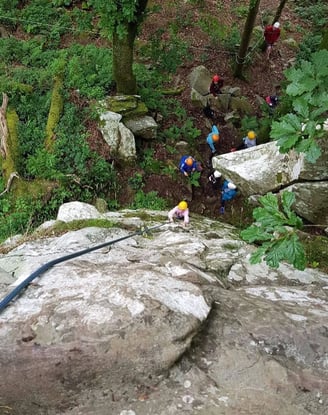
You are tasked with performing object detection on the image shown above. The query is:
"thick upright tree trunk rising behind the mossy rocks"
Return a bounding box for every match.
[113,23,137,95]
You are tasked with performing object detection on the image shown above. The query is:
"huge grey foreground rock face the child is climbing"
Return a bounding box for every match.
[0,202,328,415]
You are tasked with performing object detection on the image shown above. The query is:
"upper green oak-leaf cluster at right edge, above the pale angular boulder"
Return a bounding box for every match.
[270,50,328,163]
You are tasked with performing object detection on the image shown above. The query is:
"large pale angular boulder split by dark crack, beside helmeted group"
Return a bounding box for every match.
[212,140,328,225]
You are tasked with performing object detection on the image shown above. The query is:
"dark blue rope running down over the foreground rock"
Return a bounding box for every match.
[0,223,166,313]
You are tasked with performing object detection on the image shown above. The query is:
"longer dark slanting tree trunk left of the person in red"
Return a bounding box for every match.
[234,0,261,78]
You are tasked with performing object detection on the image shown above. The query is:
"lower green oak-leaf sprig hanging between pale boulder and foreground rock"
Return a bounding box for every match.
[241,191,306,270]
